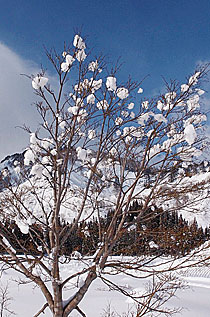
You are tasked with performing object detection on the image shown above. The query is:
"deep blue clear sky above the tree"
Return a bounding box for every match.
[0,0,210,159]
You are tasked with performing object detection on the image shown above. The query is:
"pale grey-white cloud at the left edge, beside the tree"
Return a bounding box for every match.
[0,43,38,160]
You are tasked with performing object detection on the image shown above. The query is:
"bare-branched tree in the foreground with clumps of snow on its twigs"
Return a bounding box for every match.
[0,35,209,317]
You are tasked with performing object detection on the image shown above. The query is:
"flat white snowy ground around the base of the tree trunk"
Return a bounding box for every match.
[1,262,210,317]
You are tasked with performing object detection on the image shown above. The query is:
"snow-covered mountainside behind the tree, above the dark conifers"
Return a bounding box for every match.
[0,150,210,230]
